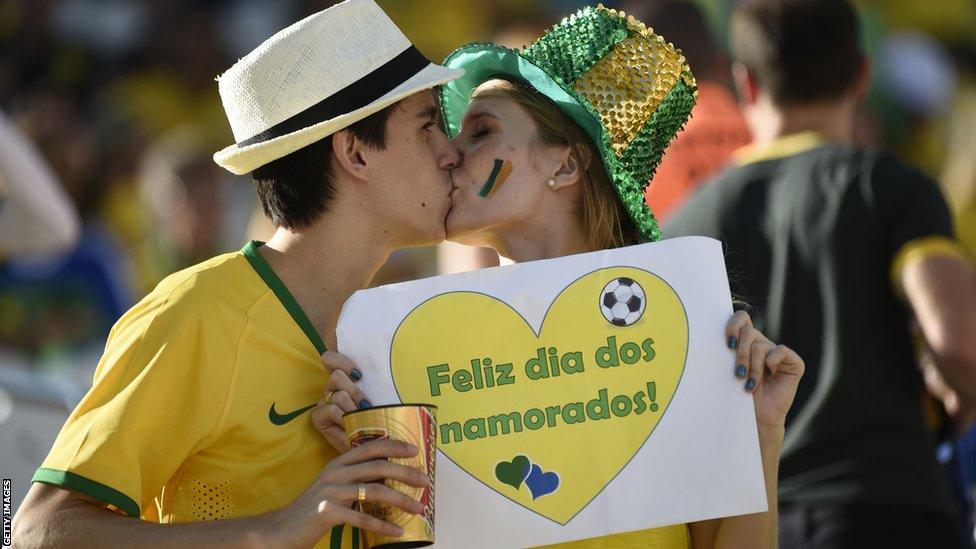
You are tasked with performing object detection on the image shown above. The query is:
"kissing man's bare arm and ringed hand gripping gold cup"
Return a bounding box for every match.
[12,440,429,549]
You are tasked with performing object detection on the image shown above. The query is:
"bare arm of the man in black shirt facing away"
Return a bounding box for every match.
[900,255,976,402]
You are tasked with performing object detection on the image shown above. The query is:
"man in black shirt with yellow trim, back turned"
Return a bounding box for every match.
[665,0,976,548]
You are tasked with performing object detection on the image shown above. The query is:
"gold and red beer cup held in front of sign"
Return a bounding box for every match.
[342,404,437,549]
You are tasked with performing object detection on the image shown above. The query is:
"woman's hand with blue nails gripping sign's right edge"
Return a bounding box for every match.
[725,311,804,430]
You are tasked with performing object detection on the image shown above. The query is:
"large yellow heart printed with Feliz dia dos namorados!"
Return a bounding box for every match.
[390,267,688,524]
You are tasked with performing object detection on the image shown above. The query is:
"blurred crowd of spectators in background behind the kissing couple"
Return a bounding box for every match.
[0,0,976,524]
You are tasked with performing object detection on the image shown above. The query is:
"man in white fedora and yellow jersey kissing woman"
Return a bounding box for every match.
[13,0,461,547]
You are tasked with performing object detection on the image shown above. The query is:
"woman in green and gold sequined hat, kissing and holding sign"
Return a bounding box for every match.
[313,6,804,549]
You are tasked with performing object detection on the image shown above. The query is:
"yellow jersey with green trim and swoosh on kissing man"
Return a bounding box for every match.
[34,242,359,549]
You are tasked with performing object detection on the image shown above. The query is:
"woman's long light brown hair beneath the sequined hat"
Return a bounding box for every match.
[471,79,643,250]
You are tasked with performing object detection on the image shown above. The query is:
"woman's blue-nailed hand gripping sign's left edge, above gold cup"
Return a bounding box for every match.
[312,351,371,453]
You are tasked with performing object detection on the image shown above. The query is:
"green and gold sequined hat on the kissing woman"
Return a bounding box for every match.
[441,4,697,241]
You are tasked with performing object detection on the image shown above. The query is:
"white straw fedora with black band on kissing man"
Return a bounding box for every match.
[214,0,464,175]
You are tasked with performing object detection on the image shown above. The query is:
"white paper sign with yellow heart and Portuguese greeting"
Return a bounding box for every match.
[337,237,766,548]
